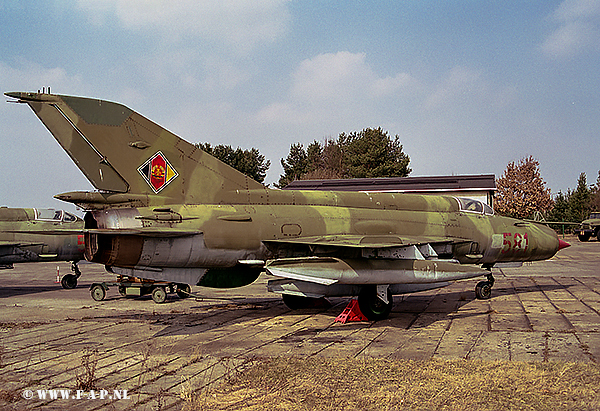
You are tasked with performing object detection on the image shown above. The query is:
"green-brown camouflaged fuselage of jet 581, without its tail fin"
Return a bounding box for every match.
[74,190,559,290]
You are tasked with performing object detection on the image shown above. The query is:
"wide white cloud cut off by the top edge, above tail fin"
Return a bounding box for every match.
[78,0,291,53]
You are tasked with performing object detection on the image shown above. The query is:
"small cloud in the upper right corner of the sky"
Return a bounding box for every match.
[541,0,600,58]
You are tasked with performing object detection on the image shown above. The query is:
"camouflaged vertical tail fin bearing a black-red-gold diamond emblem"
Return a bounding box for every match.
[6,92,263,204]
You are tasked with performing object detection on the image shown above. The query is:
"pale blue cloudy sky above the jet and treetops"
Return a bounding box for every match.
[0,0,600,212]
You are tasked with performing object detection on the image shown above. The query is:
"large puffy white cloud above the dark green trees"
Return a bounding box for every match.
[257,51,518,127]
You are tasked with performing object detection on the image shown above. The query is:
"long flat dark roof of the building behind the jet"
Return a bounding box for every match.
[283,174,496,193]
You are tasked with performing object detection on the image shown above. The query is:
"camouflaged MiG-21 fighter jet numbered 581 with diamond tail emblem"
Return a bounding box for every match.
[6,92,568,320]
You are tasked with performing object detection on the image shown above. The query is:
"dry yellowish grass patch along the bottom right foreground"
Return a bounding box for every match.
[184,358,600,411]
